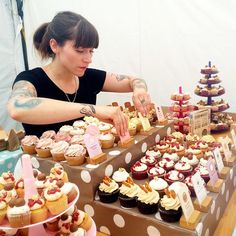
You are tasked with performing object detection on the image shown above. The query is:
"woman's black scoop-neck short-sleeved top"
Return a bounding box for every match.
[14,67,106,137]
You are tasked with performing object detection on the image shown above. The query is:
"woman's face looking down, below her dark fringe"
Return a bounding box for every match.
[56,41,93,77]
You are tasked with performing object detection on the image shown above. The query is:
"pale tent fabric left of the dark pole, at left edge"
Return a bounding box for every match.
[0,0,24,131]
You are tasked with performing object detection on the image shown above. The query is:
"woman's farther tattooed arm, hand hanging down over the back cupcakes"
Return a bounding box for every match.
[103,73,151,115]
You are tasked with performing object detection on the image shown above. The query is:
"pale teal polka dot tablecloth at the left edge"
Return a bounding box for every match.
[0,149,22,174]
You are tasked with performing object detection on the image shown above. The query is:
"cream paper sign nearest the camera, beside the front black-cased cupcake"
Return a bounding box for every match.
[169,182,194,222]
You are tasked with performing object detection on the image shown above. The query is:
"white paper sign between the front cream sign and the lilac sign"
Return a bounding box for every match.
[191,171,207,205]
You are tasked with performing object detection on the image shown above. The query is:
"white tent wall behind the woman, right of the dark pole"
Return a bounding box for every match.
[25,0,236,111]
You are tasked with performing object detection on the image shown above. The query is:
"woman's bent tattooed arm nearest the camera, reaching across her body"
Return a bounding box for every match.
[7,80,127,134]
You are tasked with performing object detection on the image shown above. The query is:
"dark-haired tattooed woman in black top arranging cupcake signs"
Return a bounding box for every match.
[8,12,150,136]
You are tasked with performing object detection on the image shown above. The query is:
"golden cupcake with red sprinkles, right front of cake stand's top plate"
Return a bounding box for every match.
[44,186,68,215]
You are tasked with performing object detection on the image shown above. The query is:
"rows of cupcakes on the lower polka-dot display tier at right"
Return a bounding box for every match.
[95,132,229,214]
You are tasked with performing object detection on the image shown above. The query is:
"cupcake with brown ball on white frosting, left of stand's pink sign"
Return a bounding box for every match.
[7,198,31,228]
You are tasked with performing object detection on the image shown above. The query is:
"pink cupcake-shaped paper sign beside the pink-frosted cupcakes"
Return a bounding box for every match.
[84,125,102,158]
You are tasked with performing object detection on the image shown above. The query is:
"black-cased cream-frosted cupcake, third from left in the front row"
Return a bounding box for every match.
[137,183,160,215]
